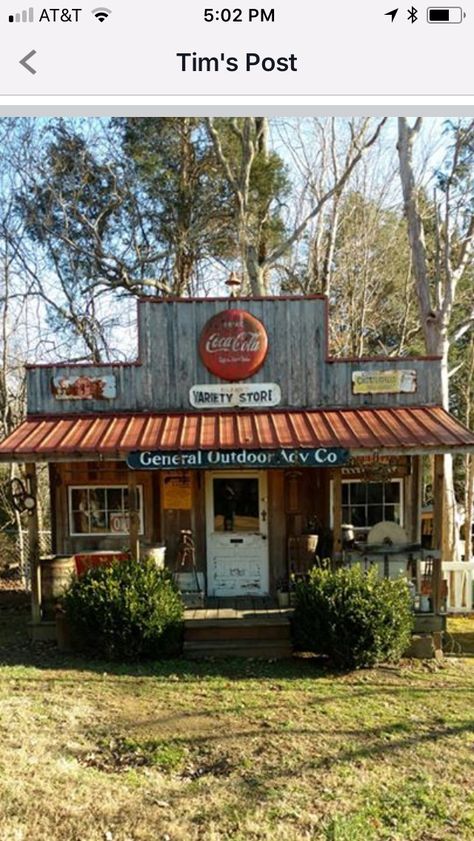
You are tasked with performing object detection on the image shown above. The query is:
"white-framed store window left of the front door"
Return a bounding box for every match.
[69,485,143,535]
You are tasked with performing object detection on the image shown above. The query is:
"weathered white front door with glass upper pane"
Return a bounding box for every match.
[206,471,269,596]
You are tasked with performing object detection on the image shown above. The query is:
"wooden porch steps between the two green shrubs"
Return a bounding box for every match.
[184,616,292,658]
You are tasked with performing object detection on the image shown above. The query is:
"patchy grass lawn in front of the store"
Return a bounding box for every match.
[0,610,474,841]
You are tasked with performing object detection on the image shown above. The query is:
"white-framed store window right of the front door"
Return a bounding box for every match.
[342,479,403,528]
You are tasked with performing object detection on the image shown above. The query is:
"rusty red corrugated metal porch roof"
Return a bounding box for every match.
[0,406,474,462]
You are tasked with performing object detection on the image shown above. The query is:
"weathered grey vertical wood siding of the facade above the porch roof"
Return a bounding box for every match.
[28,298,441,414]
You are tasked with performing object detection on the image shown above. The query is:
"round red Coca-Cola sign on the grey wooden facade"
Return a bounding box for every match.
[199,310,268,380]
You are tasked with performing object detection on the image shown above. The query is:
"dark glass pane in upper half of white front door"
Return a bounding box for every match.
[213,478,259,532]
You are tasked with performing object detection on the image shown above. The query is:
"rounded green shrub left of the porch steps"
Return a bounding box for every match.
[62,560,183,660]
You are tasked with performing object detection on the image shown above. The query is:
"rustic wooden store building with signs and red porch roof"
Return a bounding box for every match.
[0,296,474,644]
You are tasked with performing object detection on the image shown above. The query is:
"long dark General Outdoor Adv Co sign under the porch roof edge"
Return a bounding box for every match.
[127,447,350,470]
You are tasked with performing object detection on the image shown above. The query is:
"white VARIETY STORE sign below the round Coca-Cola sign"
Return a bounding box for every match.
[189,383,281,409]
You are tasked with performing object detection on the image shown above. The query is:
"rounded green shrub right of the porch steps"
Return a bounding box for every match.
[293,567,413,668]
